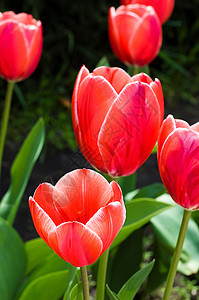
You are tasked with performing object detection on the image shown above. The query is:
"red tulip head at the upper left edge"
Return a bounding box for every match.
[0,11,43,81]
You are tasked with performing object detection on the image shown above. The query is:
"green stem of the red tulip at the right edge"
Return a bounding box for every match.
[162,210,192,300]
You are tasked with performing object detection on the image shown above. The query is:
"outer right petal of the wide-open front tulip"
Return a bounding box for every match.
[86,201,126,253]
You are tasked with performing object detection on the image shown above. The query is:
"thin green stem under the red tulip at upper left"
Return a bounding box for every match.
[0,81,14,182]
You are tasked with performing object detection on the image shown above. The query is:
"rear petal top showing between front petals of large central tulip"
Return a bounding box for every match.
[93,67,131,94]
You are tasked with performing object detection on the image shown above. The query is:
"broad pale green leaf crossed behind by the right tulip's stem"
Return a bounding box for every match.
[151,206,199,275]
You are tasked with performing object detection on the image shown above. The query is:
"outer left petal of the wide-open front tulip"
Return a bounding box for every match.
[29,197,56,245]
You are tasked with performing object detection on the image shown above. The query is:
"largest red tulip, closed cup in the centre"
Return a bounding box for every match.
[72,66,164,176]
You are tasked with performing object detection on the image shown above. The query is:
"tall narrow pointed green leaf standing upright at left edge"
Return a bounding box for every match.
[0,119,45,224]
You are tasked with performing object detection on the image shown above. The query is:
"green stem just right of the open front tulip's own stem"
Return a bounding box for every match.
[96,248,109,300]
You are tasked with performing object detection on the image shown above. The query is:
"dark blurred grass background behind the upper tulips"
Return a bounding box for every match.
[0,0,199,151]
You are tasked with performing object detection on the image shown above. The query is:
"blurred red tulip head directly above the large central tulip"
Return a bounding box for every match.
[109,4,162,66]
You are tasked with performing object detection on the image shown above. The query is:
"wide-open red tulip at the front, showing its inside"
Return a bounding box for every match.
[29,169,126,267]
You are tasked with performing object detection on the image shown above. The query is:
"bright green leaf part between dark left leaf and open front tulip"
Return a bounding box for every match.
[25,238,53,275]
